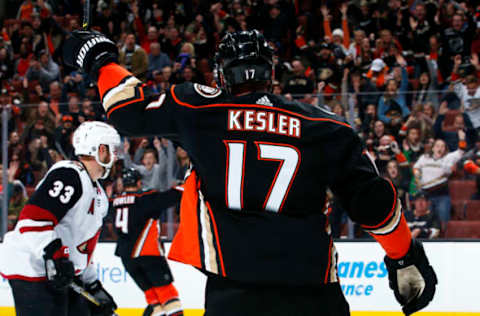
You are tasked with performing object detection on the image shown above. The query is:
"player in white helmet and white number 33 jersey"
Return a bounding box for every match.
[0,122,120,316]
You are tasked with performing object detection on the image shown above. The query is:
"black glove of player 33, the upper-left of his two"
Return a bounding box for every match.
[43,238,75,291]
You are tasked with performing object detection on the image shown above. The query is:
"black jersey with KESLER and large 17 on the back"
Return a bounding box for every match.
[99,64,393,285]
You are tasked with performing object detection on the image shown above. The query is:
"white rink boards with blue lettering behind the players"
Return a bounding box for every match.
[0,242,480,316]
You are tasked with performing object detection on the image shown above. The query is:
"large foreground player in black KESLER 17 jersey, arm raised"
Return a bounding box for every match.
[64,31,437,316]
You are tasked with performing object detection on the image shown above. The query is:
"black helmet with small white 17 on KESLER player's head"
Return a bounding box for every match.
[215,30,273,92]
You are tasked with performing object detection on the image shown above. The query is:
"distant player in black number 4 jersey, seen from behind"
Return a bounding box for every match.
[111,168,183,316]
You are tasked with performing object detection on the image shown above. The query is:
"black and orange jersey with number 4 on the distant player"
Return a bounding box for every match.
[111,187,183,258]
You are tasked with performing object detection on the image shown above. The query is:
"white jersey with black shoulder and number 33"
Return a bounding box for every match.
[0,161,108,283]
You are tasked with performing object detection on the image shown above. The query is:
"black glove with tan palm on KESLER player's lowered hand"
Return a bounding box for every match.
[384,239,437,316]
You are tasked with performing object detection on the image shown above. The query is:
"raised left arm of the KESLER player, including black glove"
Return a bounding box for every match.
[64,31,176,136]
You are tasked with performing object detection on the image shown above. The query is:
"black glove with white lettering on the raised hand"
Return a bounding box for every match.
[63,31,118,81]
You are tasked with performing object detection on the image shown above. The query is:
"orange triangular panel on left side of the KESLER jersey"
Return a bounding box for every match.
[168,171,202,269]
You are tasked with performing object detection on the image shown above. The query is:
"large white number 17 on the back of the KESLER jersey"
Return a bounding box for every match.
[224,140,300,212]
